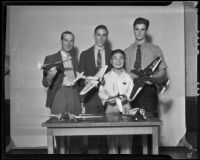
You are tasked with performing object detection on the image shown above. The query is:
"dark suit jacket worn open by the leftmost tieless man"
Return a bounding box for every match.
[42,51,78,108]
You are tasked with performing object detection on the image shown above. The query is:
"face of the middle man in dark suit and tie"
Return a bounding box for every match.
[94,29,108,47]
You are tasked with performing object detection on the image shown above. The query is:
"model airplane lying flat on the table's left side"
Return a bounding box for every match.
[43,112,103,121]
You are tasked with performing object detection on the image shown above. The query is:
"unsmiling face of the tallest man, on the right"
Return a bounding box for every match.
[134,24,147,41]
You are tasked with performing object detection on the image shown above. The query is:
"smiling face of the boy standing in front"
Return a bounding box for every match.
[110,52,125,69]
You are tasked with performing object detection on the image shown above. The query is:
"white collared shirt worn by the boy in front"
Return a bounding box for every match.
[98,69,133,104]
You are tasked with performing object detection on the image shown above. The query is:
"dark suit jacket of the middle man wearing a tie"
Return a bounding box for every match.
[79,46,112,114]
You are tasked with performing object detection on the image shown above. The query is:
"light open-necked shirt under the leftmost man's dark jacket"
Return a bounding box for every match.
[61,50,75,86]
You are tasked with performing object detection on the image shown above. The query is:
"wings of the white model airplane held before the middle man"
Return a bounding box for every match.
[79,65,108,95]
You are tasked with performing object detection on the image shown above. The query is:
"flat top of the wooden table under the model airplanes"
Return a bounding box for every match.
[42,114,163,128]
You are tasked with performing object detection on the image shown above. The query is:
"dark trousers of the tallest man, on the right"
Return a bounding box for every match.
[131,85,158,154]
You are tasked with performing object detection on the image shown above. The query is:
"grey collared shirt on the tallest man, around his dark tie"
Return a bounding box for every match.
[125,42,167,73]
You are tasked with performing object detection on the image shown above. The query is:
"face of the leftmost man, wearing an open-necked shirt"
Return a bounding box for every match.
[62,34,74,52]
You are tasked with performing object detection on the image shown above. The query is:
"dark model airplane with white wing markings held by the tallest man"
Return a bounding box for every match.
[130,57,170,100]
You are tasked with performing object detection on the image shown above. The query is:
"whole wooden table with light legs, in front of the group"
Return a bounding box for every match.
[42,114,162,154]
